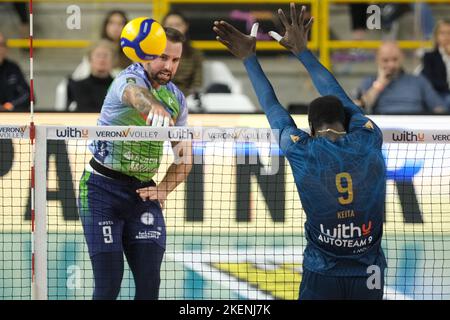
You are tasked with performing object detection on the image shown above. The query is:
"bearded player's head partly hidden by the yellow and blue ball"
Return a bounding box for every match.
[145,28,185,85]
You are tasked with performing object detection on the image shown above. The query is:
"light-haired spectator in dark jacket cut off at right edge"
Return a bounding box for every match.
[422,19,450,110]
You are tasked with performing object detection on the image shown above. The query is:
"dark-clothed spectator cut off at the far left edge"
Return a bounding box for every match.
[0,32,30,111]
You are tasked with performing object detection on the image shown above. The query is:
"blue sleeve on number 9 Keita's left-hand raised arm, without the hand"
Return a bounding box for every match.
[244,55,295,130]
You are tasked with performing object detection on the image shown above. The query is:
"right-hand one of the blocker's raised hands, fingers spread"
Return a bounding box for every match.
[269,2,313,55]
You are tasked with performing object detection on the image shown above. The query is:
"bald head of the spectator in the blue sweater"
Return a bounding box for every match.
[377,41,403,77]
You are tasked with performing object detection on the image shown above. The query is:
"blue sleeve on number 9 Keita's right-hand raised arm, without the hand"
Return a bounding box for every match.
[296,50,362,115]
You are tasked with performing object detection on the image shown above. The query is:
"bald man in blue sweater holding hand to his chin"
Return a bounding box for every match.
[358,42,446,114]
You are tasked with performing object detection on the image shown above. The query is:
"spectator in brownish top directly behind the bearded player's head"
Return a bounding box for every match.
[162,11,203,96]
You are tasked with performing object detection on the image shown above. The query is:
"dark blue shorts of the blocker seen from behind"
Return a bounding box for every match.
[298,268,384,300]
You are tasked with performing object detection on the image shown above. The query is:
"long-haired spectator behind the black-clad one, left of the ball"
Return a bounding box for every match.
[72,10,132,80]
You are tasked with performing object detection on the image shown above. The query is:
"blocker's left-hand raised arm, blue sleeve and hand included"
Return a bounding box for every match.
[213,21,296,130]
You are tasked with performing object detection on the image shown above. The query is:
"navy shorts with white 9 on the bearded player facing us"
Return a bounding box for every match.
[78,171,166,257]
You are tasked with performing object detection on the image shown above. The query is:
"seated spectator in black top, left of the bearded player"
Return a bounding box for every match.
[67,40,114,112]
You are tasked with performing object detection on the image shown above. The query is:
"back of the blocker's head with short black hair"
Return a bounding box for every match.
[308,96,345,136]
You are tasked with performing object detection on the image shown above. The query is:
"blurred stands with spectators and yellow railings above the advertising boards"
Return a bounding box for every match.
[0,0,450,115]
